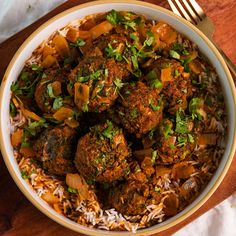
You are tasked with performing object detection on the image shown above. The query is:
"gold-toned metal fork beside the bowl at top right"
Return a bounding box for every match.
[168,0,236,77]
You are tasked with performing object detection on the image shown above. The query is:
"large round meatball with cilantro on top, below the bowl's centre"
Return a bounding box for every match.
[75,121,130,182]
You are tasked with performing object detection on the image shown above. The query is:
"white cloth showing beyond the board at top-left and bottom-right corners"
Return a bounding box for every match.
[0,0,236,236]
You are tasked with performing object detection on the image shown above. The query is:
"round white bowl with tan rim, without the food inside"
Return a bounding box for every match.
[0,0,236,235]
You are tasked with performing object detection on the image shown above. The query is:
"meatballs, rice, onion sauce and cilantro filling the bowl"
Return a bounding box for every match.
[10,10,227,232]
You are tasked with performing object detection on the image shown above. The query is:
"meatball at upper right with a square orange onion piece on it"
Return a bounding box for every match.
[148,59,193,114]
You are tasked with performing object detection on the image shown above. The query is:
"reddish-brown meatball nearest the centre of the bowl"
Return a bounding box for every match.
[117,82,163,138]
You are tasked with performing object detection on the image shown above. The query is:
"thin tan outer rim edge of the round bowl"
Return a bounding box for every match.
[0,0,236,235]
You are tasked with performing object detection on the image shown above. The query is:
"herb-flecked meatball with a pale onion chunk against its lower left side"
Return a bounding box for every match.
[69,56,129,112]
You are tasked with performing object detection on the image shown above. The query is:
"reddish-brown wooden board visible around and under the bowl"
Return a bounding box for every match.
[0,0,236,236]
